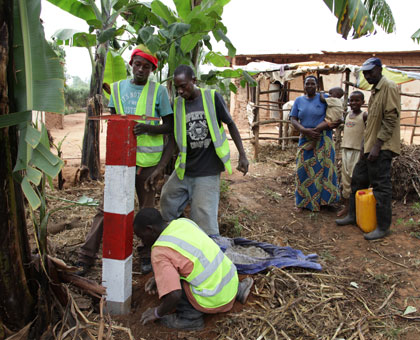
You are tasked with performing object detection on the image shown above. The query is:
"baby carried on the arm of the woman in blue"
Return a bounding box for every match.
[304,87,344,150]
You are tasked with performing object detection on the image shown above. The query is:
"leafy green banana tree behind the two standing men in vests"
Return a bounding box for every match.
[48,0,253,179]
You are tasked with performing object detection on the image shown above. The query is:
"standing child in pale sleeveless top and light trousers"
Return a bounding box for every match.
[337,91,367,216]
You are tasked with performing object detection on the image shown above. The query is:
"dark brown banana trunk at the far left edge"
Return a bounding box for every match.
[0,5,36,338]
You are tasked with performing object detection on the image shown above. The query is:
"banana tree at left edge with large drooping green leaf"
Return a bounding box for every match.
[0,0,64,338]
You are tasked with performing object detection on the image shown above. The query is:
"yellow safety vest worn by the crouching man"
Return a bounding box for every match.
[152,218,239,308]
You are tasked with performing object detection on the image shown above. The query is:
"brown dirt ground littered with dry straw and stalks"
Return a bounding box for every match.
[42,115,420,340]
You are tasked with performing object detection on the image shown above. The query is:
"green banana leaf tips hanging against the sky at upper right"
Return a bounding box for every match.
[324,0,396,39]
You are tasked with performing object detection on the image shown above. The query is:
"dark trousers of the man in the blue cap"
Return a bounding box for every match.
[349,150,393,231]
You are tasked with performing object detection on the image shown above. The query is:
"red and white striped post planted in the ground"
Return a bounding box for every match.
[102,116,137,315]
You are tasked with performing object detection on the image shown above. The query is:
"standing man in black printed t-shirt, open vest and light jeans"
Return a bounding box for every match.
[151,65,249,235]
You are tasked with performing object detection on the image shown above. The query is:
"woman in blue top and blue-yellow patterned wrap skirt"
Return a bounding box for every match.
[290,76,341,211]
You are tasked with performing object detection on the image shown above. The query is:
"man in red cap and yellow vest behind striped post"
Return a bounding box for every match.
[78,45,173,275]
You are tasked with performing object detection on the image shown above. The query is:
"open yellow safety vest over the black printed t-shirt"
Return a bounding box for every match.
[174,89,232,180]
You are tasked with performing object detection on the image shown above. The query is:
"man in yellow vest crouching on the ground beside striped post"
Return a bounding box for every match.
[134,208,253,330]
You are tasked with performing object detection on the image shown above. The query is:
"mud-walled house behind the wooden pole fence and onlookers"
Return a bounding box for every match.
[230,50,420,143]
